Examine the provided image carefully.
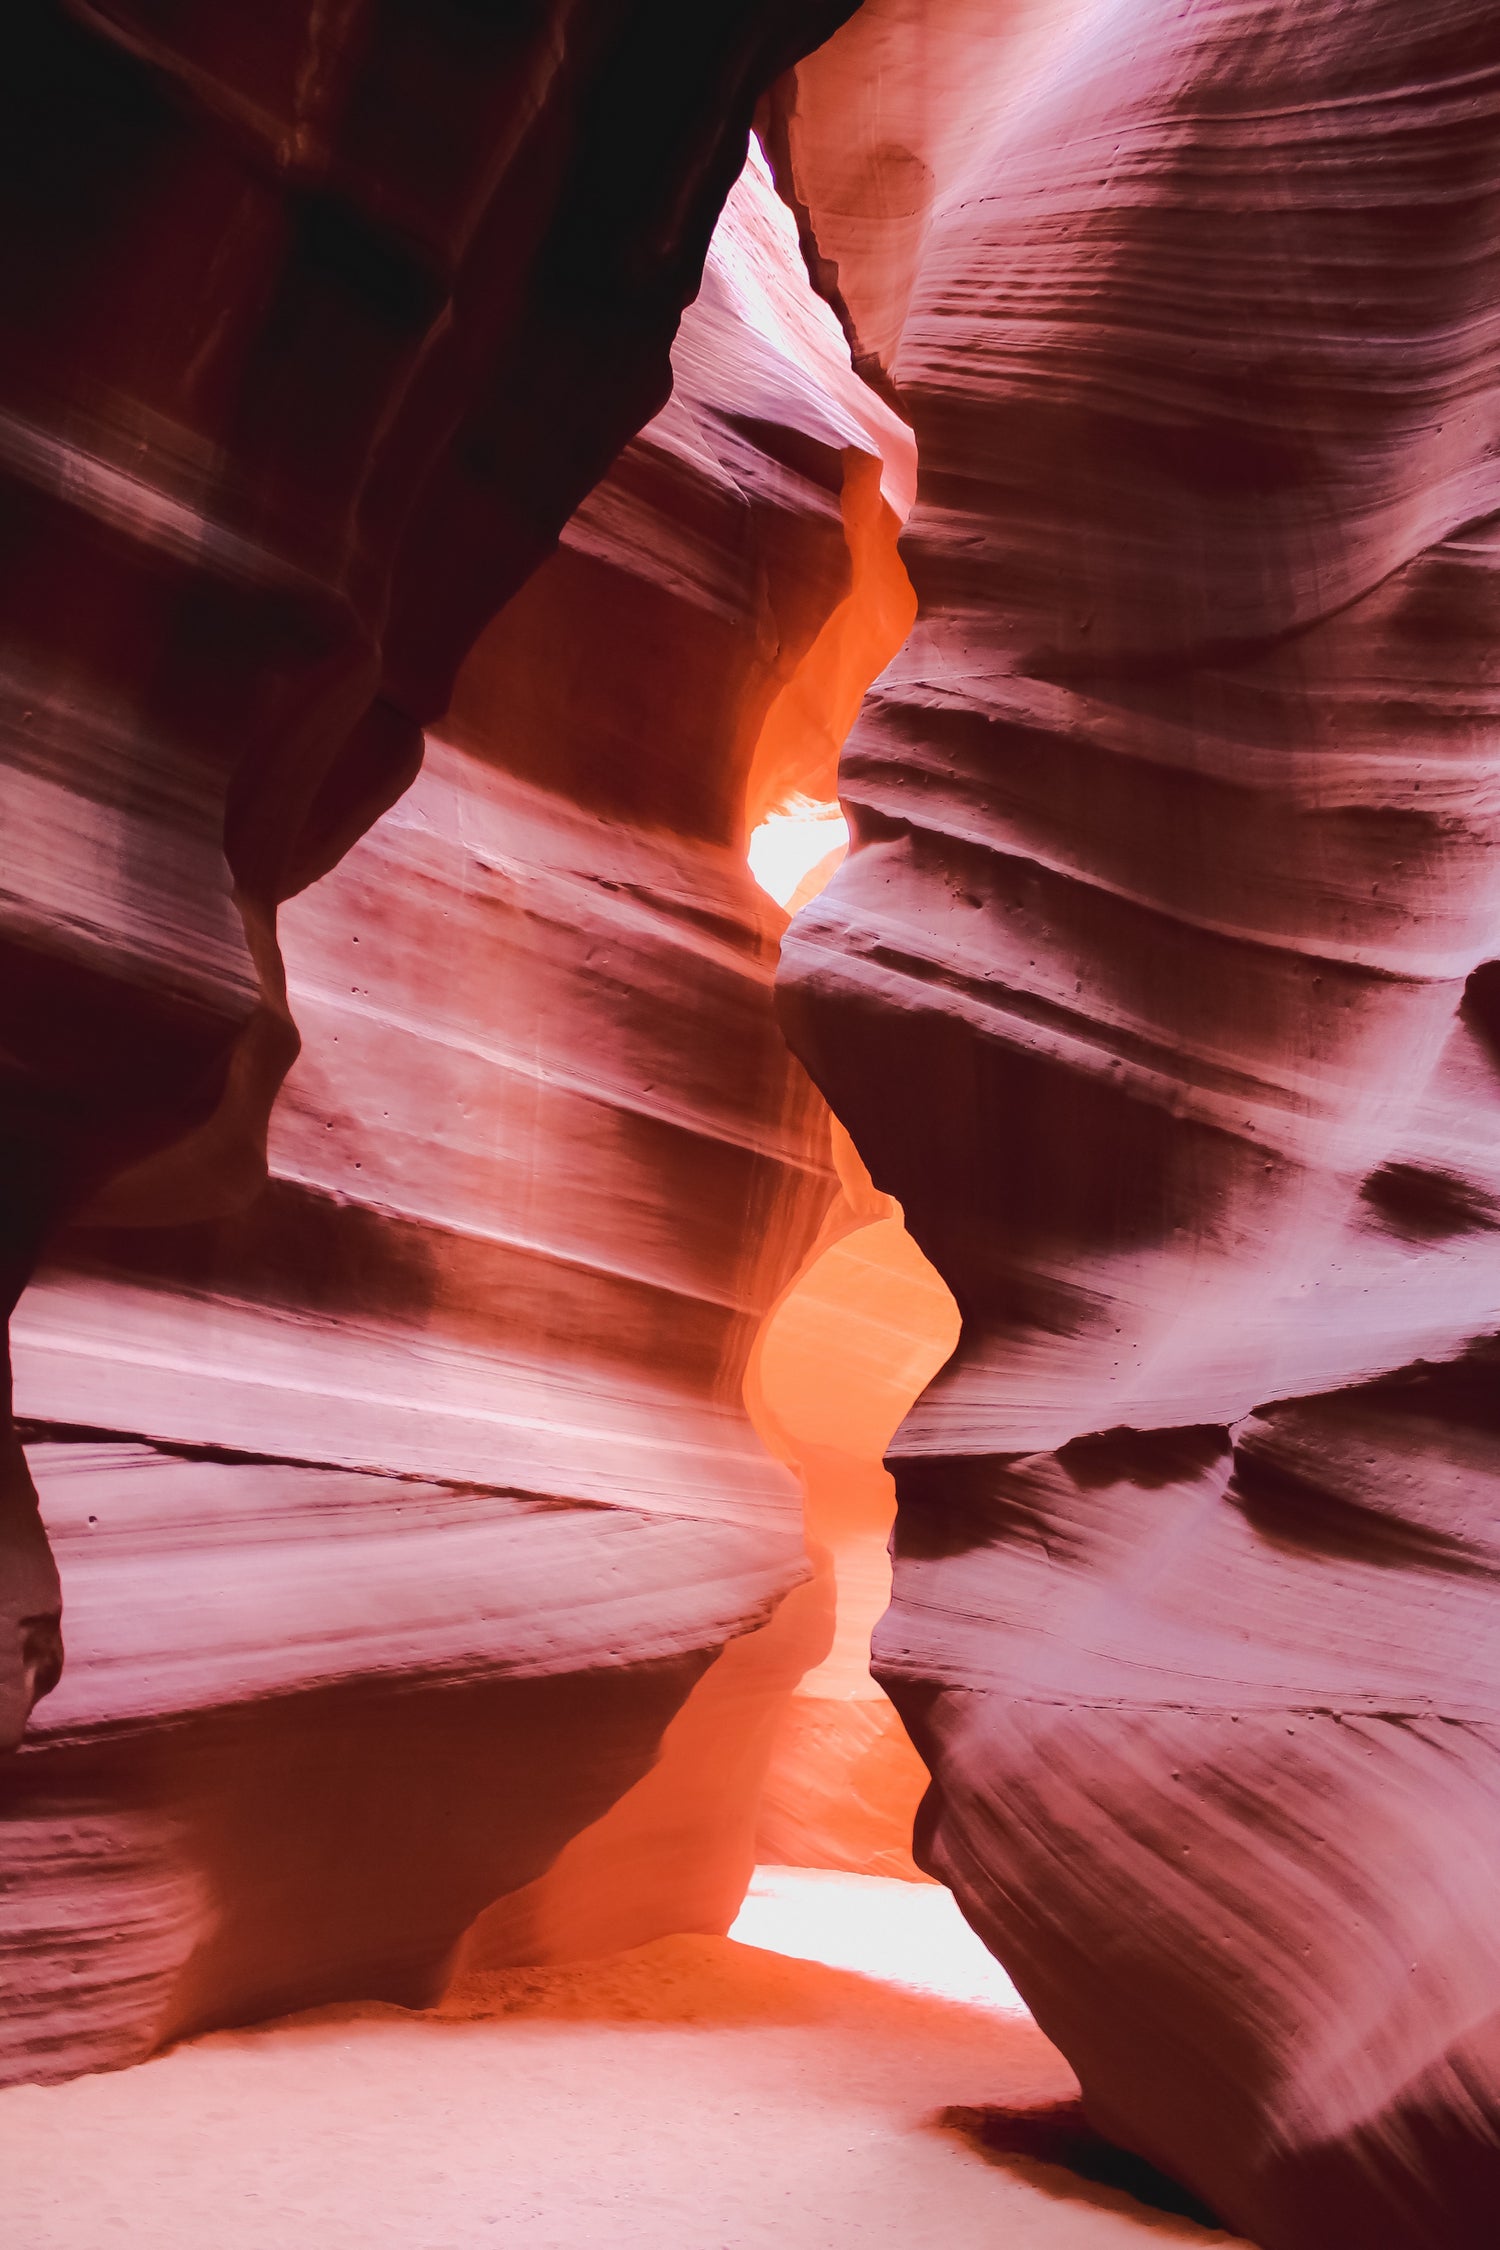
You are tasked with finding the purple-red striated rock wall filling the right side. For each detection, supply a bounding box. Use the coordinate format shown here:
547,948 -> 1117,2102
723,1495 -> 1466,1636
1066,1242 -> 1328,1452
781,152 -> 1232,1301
778,0 -> 1500,2250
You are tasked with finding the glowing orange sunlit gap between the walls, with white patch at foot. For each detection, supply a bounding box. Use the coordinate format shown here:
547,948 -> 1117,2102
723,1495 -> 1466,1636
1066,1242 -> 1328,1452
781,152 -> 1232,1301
731,652 -> 962,2009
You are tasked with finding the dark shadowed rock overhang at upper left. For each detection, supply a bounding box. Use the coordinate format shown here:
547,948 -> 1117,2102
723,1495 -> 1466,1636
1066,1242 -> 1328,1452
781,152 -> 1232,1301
0,0 -> 868,1742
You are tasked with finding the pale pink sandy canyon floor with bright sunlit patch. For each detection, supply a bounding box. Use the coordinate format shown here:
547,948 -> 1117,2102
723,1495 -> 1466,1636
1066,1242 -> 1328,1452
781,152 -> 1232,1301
0,1870 -> 1259,2250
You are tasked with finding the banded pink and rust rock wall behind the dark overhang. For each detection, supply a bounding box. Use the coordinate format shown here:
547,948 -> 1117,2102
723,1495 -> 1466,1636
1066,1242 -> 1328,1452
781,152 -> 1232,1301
0,136 -> 917,2077
